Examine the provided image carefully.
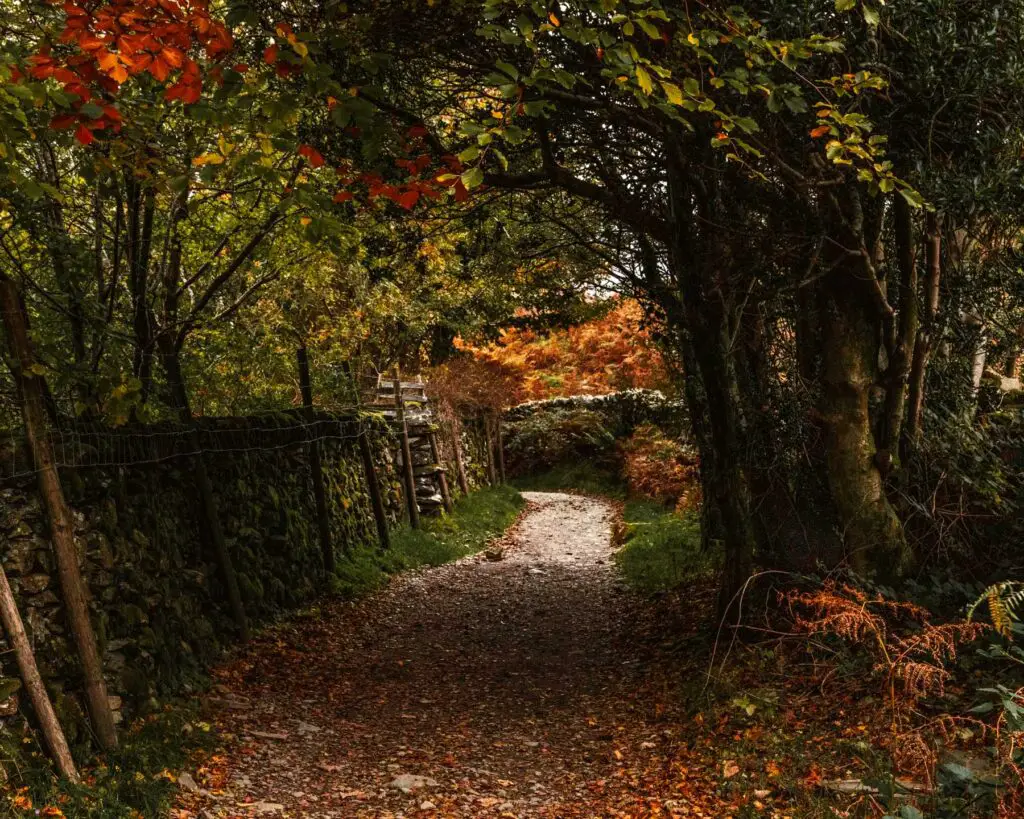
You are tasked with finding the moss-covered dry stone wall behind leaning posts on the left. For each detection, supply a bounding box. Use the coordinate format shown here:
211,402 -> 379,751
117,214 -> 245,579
0,414 -> 417,741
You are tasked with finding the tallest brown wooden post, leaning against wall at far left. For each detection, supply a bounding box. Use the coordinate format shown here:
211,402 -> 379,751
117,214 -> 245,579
0,273 -> 118,750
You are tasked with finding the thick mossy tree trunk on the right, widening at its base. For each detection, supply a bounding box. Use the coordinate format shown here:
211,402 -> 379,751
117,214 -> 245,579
821,261 -> 909,576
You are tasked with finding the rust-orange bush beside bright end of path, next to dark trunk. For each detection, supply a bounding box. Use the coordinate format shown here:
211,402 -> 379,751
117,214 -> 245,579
620,424 -> 700,510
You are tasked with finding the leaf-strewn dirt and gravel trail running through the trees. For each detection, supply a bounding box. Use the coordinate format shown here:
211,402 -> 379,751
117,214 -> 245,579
179,492 -> 716,817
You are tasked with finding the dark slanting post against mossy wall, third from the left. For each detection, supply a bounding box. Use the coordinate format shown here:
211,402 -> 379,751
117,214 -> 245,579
158,333 -> 249,643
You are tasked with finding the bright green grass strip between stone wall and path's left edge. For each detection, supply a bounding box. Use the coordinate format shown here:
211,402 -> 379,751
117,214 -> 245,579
334,486 -> 525,598
